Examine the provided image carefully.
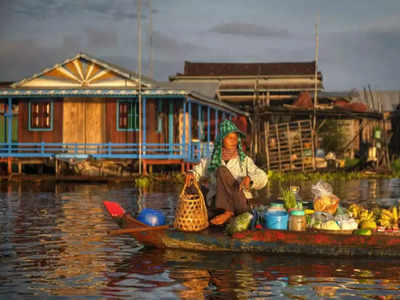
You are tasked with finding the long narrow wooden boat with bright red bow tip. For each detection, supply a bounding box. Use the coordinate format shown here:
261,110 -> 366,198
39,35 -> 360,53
104,201 -> 400,257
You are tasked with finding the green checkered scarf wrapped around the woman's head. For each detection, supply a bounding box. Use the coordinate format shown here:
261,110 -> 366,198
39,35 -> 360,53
208,120 -> 246,173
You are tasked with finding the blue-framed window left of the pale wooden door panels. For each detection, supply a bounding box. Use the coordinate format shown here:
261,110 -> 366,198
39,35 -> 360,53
29,101 -> 53,131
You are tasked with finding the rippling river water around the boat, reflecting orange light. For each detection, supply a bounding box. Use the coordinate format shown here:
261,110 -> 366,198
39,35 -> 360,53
0,179 -> 400,299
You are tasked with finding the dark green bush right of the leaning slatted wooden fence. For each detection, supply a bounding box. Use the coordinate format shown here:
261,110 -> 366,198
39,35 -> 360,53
318,120 -> 346,154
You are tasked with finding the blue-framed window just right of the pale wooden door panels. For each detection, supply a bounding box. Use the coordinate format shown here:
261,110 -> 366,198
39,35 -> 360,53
117,100 -> 139,130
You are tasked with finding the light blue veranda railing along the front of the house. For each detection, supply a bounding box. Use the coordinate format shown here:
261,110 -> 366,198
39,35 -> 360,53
0,142 -> 212,163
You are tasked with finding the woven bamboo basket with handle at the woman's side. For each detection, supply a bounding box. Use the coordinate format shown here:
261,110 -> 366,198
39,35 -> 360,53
174,181 -> 208,231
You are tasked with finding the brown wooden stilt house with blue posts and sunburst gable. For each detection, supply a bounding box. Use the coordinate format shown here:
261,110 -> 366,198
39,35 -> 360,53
0,53 -> 247,175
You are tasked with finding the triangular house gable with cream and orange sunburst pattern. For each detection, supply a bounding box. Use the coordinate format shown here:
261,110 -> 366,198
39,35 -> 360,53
12,54 -> 151,88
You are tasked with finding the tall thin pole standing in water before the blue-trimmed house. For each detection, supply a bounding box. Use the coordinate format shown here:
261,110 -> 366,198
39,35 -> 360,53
137,0 -> 142,175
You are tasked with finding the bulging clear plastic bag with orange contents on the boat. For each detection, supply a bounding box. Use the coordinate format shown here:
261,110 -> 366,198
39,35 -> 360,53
311,180 -> 340,215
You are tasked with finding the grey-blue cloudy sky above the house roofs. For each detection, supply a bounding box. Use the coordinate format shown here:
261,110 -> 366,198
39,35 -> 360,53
0,0 -> 400,91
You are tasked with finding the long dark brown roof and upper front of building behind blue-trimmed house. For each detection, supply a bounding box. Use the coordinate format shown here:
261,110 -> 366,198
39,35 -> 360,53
169,61 -> 323,111
